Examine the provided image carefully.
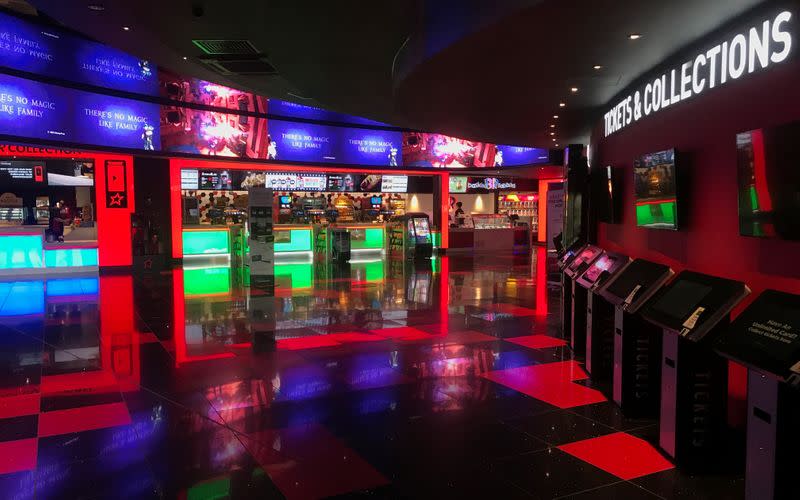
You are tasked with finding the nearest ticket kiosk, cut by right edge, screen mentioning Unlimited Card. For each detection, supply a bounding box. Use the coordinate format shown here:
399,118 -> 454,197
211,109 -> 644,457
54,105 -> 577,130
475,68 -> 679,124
714,290 -> 800,500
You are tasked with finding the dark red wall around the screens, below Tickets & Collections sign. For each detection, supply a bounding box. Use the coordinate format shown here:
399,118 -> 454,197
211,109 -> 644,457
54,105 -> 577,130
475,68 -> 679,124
592,61 -> 800,300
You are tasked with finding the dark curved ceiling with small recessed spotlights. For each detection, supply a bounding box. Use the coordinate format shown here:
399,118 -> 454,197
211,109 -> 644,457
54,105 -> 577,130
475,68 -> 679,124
31,0 -> 761,147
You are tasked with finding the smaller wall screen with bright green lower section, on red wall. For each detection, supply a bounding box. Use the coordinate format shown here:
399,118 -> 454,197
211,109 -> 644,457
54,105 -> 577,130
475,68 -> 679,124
633,149 -> 678,230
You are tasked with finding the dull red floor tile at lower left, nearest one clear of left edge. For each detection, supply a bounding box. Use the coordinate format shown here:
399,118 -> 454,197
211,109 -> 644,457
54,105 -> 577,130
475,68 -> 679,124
39,403 -> 131,437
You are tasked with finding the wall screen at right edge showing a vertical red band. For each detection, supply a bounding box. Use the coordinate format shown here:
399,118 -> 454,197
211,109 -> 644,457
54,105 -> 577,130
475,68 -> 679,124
736,121 -> 800,240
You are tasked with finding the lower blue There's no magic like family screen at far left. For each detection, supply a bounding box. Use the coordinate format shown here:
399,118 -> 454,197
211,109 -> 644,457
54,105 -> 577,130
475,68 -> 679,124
0,75 -> 160,151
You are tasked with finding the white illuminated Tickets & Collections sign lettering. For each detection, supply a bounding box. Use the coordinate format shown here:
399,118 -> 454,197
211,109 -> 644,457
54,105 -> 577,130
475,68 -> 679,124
604,10 -> 796,137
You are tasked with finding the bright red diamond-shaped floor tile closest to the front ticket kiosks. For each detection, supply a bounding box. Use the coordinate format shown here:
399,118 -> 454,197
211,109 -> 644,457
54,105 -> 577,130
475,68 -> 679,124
558,432 -> 675,480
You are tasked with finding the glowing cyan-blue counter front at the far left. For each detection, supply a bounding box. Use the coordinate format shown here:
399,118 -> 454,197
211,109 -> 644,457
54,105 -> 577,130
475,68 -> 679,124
0,226 -> 99,275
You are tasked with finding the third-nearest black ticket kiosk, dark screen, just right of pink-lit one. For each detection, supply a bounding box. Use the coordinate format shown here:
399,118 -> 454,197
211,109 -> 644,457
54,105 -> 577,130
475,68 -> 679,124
597,259 -> 674,417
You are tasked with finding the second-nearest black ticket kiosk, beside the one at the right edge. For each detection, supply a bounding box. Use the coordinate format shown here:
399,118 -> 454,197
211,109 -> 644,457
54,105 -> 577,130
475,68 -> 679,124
641,271 -> 750,469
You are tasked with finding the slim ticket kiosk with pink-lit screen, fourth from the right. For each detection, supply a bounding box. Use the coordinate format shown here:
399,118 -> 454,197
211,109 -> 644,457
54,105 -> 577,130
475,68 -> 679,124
576,251 -> 630,380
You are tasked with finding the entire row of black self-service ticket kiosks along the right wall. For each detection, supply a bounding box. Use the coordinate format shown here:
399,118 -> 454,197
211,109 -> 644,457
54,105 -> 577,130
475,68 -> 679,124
559,245 -> 800,499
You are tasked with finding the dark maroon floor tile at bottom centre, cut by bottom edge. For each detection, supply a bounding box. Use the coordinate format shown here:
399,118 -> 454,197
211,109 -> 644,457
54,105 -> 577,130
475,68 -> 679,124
245,424 -> 389,500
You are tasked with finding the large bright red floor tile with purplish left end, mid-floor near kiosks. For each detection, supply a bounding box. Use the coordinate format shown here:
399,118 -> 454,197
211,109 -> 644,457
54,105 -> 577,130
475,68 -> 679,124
481,361 -> 606,408
